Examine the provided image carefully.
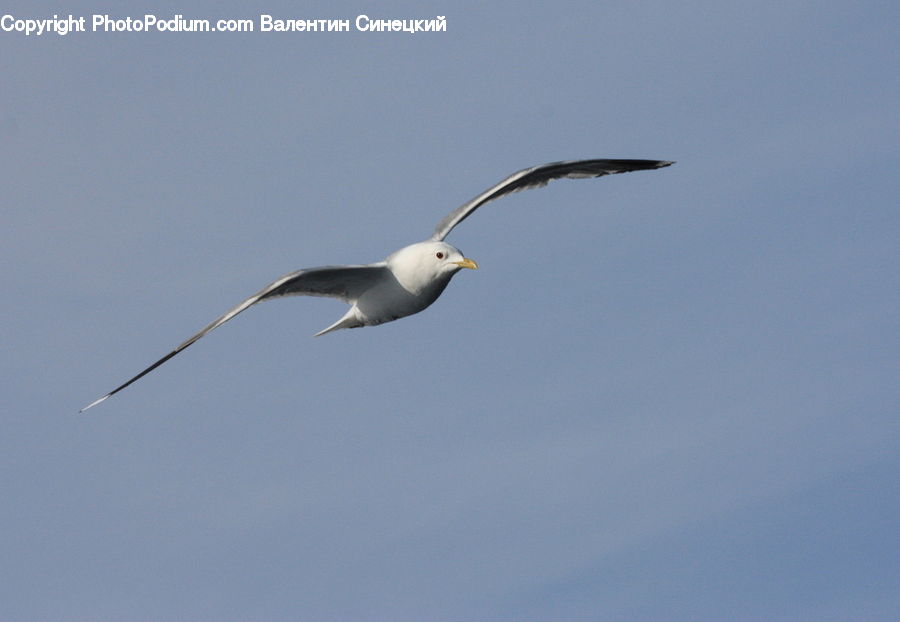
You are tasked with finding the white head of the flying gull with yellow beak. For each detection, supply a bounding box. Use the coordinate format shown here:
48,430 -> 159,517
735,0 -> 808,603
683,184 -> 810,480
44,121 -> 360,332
385,241 -> 478,293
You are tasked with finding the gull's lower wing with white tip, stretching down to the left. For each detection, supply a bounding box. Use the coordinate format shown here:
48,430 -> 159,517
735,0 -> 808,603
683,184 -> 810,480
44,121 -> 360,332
78,263 -> 387,412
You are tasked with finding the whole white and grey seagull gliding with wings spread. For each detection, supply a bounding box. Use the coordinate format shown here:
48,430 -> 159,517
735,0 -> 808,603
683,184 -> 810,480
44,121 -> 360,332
78,159 -> 674,412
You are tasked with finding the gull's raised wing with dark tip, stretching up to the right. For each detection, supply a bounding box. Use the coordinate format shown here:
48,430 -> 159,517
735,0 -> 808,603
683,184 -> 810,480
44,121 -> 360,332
431,160 -> 674,241
